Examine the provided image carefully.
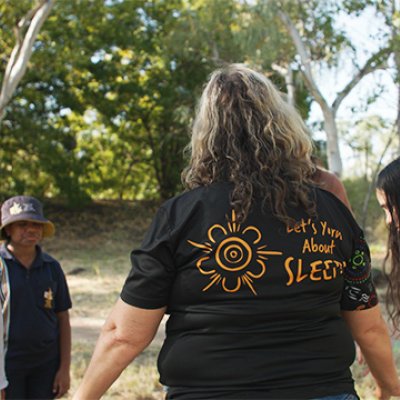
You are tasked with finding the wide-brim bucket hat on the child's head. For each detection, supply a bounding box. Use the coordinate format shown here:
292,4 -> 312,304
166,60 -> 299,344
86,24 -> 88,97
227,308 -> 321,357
0,196 -> 55,239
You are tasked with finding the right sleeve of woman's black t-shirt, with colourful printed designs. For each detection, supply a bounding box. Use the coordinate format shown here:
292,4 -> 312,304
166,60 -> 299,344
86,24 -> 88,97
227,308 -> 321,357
341,230 -> 378,311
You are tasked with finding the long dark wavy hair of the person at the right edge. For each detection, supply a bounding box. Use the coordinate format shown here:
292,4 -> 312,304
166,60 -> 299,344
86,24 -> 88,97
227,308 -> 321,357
376,157 -> 400,331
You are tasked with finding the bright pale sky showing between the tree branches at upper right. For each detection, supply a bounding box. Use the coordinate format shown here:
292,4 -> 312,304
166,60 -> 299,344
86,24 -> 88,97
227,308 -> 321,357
308,6 -> 398,176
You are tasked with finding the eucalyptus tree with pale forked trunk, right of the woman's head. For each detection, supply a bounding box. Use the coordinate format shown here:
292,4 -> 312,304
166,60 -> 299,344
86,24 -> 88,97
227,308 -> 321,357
244,0 -> 389,175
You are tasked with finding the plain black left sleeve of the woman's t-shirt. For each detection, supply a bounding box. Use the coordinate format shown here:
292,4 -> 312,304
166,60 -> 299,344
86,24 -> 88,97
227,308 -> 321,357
121,208 -> 175,309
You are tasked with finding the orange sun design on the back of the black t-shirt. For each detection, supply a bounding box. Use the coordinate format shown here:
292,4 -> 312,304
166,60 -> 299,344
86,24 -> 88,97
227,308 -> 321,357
188,210 -> 282,295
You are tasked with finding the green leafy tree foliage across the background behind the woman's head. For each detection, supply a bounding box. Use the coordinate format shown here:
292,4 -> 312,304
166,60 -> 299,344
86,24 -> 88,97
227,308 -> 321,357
0,0 -> 378,204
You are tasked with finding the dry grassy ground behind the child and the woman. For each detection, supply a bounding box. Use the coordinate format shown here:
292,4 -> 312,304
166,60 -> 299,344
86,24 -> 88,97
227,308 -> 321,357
39,203 -> 400,400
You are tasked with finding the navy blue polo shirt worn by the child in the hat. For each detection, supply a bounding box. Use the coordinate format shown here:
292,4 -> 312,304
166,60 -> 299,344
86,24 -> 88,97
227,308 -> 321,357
0,244 -> 72,370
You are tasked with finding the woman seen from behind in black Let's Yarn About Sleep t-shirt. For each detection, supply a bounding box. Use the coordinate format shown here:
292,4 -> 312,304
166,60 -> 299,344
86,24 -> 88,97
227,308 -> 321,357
74,64 -> 400,400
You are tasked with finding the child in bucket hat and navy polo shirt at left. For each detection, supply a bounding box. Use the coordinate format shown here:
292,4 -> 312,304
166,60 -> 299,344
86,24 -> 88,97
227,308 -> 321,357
0,196 -> 71,399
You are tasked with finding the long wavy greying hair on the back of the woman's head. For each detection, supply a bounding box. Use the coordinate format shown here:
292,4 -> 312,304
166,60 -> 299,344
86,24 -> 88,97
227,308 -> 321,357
183,64 -> 314,222
